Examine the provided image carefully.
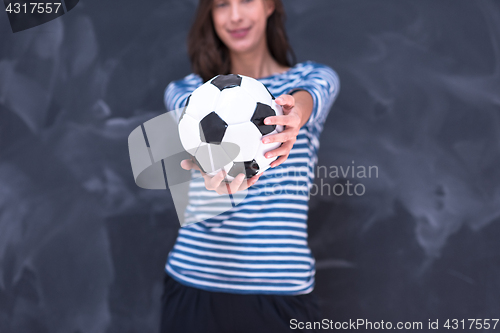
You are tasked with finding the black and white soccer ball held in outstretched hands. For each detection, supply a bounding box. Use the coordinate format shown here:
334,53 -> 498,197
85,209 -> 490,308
179,74 -> 283,181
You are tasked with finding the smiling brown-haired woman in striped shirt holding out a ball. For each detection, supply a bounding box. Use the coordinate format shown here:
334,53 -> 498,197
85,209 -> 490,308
161,0 -> 339,333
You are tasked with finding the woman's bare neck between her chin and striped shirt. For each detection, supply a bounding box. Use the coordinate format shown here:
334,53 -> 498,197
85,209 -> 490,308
230,40 -> 287,79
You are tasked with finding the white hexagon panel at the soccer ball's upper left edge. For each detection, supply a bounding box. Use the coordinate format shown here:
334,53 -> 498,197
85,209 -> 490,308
186,84 -> 220,121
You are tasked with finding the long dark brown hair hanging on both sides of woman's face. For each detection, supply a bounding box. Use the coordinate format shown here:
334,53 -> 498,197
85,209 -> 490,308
187,0 -> 296,82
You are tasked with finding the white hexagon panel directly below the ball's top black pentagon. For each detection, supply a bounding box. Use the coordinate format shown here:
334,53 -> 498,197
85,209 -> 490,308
215,87 -> 257,124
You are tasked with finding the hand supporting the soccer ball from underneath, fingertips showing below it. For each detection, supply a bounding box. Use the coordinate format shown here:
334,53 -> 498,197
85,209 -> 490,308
181,160 -> 260,194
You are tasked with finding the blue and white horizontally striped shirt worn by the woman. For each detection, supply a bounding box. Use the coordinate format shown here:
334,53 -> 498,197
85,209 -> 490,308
164,61 -> 340,295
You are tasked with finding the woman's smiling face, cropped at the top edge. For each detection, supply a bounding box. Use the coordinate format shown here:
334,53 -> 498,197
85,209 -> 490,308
212,0 -> 274,53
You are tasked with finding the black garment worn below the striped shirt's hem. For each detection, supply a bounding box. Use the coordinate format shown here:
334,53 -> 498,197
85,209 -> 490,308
160,274 -> 321,333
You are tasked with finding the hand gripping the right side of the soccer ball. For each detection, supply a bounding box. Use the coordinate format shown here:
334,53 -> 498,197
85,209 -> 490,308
262,94 -> 301,168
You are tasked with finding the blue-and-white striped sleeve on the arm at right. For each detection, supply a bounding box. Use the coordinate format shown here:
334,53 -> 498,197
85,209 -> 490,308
288,61 -> 340,127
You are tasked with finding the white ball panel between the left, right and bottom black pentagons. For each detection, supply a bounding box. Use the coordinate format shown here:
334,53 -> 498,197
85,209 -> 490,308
223,121 -> 262,161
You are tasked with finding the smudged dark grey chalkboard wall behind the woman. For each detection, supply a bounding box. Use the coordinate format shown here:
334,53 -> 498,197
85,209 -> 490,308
0,0 -> 500,333
